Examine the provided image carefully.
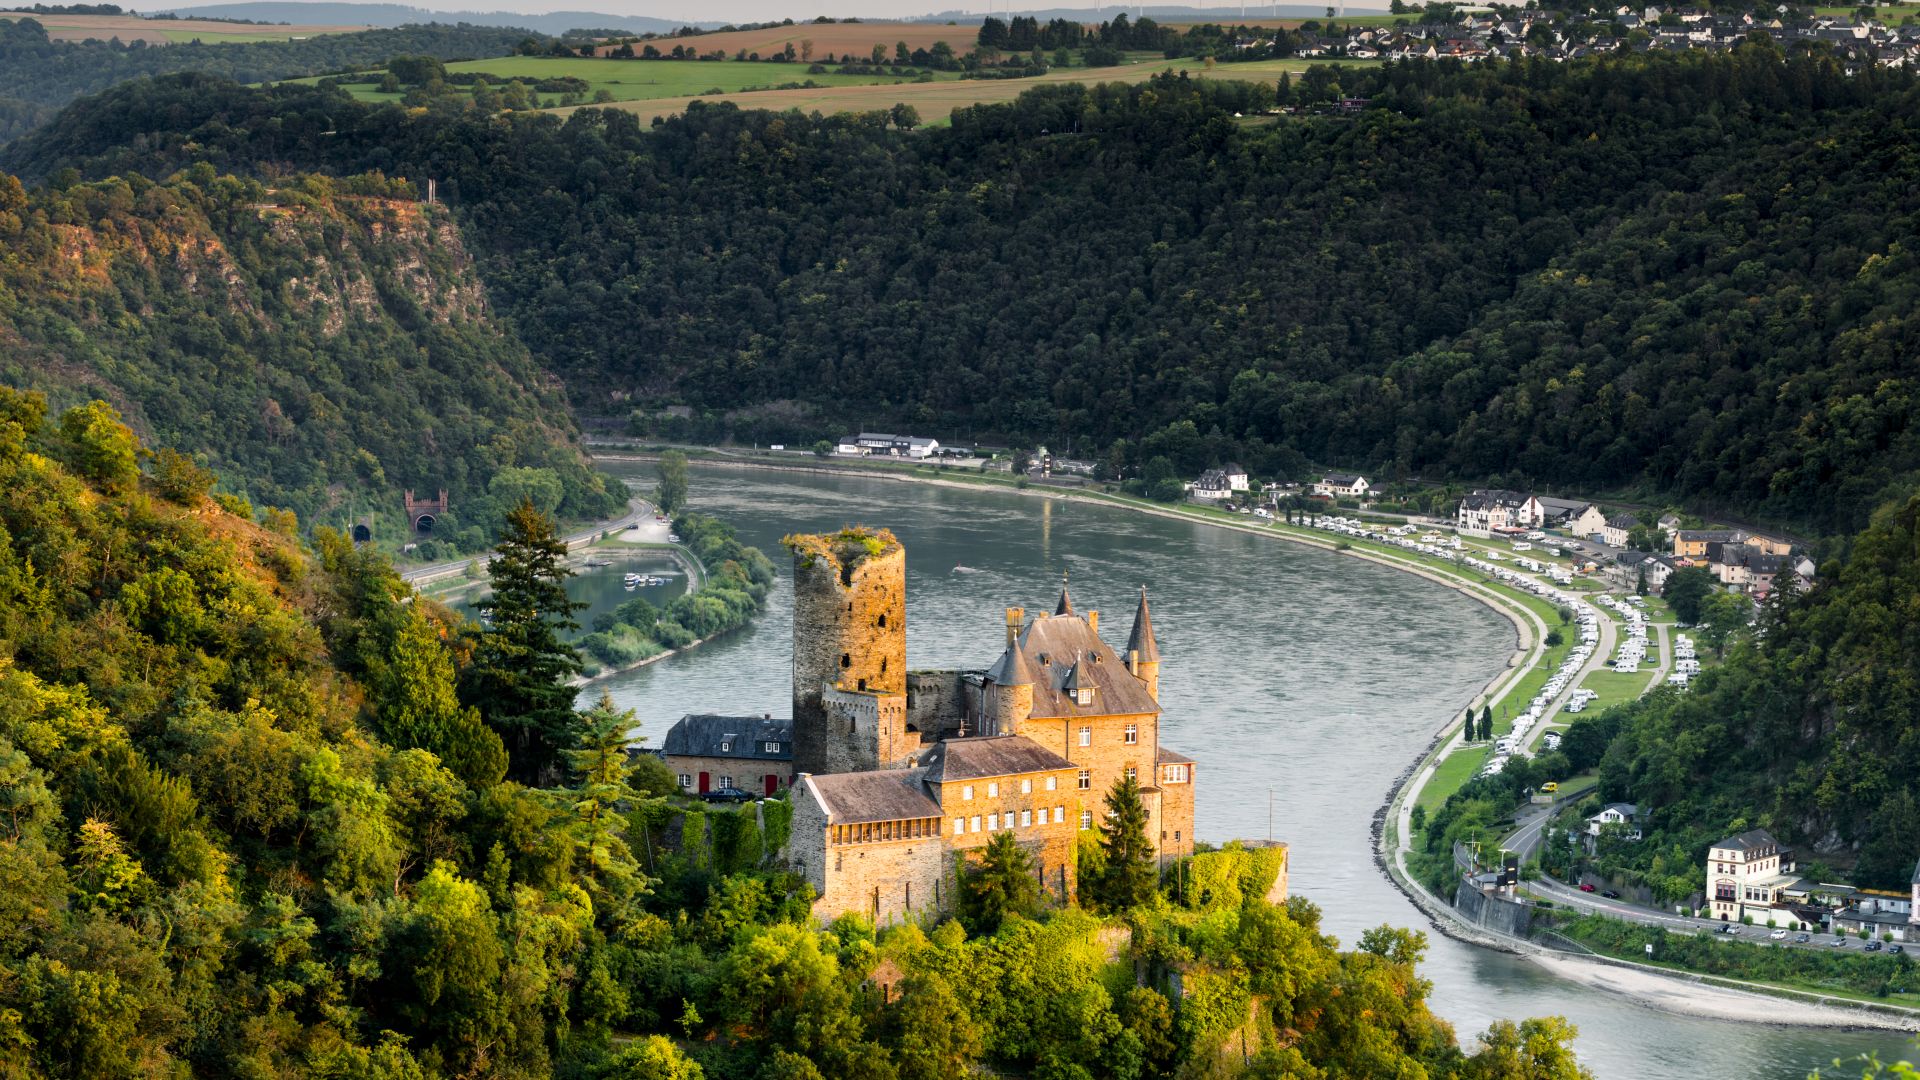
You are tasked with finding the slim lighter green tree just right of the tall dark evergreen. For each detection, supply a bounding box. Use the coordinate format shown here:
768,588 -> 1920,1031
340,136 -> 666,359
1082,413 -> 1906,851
566,692 -> 647,899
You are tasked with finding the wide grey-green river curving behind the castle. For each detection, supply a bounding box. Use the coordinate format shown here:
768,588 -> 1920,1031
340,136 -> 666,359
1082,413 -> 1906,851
591,457 -> 1908,1080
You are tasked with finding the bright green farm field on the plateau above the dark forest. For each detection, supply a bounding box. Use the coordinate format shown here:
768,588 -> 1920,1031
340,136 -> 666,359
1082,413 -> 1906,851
296,56 -> 954,111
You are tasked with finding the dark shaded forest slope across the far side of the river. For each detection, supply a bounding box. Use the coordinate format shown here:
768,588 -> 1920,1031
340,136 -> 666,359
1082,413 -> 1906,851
4,42 -> 1920,530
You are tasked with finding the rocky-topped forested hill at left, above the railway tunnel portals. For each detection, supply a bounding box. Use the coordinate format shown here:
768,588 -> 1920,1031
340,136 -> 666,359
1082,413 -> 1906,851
0,165 -> 618,548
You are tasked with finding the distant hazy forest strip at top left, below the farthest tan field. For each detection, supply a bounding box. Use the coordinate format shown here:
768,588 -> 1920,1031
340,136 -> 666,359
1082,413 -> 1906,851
0,19 -> 526,114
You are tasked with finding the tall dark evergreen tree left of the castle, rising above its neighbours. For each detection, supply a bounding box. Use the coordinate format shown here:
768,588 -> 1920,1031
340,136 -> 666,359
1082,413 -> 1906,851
467,502 -> 582,786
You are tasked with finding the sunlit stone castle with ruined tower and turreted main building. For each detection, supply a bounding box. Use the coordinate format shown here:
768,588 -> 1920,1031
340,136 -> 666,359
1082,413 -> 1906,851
771,528 -> 1194,922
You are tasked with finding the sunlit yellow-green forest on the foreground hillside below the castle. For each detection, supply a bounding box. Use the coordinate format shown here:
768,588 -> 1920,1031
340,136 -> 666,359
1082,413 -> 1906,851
0,390 -> 1590,1080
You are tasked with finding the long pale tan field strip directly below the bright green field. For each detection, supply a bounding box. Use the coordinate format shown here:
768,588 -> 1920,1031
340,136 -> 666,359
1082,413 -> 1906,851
555,60 -> 1365,125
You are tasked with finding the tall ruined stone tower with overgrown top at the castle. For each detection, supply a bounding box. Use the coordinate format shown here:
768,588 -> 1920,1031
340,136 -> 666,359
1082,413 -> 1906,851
785,528 -> 920,773
